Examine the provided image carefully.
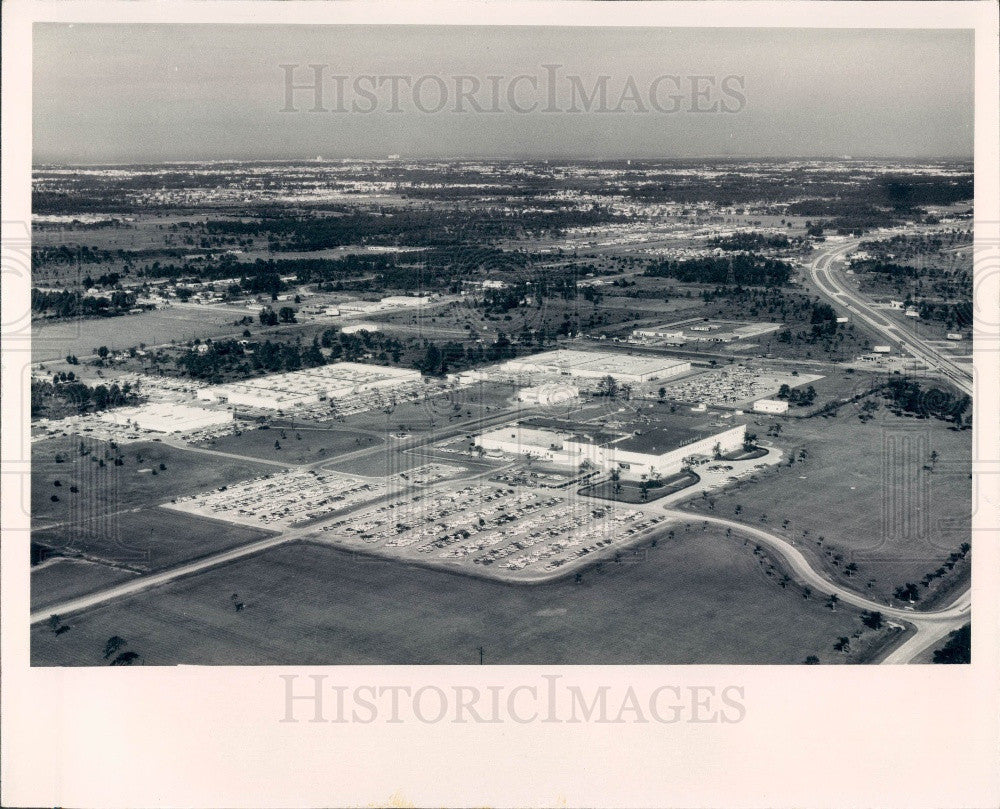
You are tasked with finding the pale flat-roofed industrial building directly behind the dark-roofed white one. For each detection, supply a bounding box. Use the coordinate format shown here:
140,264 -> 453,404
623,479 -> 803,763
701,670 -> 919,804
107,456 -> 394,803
500,348 -> 691,383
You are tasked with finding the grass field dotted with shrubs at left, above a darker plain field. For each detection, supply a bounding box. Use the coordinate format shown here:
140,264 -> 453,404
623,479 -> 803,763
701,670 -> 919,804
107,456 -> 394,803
31,436 -> 274,528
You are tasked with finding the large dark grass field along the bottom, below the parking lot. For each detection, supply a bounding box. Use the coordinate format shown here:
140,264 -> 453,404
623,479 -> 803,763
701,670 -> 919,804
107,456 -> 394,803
32,531 -> 892,665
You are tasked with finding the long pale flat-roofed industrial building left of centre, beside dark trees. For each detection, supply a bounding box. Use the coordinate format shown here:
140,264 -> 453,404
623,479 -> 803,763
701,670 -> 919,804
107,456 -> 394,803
198,362 -> 421,410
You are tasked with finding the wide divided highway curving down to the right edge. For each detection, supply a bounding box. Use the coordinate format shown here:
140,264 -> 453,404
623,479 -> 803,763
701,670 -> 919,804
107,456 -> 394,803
806,239 -> 972,396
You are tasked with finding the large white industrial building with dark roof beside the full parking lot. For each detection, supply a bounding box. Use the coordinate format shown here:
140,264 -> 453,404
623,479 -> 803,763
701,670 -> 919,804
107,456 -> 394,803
474,419 -> 746,480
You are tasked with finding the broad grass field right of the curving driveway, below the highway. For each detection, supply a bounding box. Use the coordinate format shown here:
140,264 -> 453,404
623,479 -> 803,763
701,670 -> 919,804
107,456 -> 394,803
687,406 -> 972,607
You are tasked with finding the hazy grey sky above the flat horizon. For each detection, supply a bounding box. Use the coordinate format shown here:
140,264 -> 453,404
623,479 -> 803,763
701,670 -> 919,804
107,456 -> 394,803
32,23 -> 974,164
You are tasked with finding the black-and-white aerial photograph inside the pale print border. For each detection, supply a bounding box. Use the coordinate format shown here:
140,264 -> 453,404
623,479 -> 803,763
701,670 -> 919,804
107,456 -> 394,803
30,23 -> 975,667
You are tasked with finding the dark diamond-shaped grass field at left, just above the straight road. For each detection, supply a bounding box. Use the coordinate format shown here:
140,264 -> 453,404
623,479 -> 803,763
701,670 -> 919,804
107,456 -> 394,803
32,507 -> 278,571
